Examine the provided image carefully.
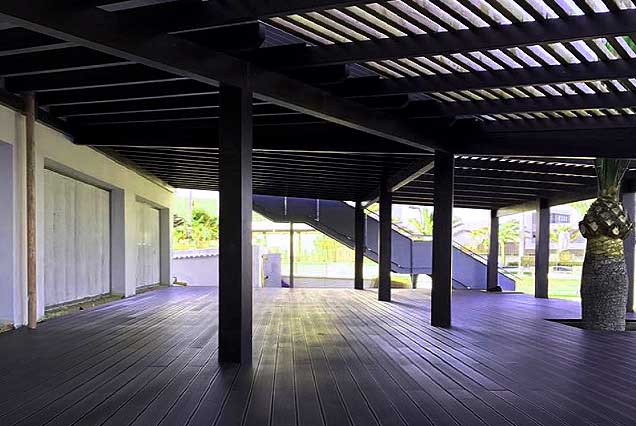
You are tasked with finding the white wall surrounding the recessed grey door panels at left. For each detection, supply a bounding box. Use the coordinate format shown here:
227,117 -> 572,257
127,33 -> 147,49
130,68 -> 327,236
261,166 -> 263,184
0,106 -> 173,325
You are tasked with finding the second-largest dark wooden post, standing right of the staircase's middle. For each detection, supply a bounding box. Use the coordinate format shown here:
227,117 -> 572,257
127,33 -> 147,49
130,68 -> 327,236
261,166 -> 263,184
431,151 -> 455,327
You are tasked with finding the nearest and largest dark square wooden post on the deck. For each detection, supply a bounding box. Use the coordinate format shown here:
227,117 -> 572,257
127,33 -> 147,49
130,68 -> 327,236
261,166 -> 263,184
219,85 -> 252,364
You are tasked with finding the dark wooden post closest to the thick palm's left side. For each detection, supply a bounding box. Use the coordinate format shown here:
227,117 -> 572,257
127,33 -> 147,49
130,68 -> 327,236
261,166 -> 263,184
534,198 -> 550,299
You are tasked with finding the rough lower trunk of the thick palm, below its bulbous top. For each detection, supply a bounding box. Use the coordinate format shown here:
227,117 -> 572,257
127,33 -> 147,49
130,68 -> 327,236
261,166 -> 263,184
581,236 -> 628,331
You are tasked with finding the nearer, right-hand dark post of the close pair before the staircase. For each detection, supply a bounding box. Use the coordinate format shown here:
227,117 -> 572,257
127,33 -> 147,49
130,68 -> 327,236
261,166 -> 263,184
378,179 -> 393,302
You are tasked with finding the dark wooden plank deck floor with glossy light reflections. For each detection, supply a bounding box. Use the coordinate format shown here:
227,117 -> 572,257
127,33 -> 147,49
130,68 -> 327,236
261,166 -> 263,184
0,288 -> 636,426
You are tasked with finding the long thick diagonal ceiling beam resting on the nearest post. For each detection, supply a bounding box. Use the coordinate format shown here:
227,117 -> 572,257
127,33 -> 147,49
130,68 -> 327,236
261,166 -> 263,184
0,0 -> 443,150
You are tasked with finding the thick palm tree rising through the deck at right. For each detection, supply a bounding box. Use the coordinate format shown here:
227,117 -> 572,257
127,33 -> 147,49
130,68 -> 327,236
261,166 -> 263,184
579,158 -> 634,331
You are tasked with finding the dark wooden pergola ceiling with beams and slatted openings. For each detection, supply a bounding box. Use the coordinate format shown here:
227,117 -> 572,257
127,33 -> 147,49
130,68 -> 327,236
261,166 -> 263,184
0,0 -> 636,211
